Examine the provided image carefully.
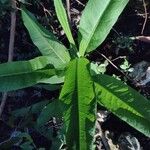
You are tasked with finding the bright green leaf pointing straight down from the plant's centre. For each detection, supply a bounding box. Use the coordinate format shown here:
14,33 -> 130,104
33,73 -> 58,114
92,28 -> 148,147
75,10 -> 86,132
59,58 -> 96,150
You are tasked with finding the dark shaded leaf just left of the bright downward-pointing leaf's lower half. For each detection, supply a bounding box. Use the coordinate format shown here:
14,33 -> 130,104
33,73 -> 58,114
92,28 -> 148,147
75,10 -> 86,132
35,100 -> 64,150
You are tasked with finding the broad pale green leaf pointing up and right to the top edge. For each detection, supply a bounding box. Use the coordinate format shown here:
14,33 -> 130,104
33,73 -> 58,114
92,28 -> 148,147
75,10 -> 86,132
79,0 -> 129,56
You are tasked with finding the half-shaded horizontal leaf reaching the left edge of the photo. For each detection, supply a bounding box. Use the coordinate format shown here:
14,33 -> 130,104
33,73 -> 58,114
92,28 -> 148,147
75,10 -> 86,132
0,56 -> 56,92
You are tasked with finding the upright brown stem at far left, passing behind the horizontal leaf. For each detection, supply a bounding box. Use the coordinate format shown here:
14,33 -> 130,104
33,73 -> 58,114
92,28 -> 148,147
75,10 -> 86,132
0,0 -> 17,117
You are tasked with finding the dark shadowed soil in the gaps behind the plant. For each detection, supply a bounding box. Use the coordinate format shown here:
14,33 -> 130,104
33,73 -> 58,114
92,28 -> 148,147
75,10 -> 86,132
0,0 -> 150,150
